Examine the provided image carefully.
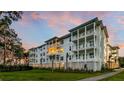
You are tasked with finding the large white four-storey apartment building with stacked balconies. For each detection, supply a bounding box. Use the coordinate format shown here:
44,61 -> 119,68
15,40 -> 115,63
29,17 -> 118,71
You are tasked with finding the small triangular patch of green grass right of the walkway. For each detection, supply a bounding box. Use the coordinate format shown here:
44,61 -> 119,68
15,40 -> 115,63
102,71 -> 124,81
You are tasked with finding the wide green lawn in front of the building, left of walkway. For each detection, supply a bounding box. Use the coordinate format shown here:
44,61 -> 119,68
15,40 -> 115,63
0,69 -> 102,81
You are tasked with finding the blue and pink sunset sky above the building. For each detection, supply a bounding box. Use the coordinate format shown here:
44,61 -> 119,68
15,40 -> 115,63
11,11 -> 124,56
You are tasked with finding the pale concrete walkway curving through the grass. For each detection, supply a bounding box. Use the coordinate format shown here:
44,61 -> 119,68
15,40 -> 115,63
79,68 -> 124,81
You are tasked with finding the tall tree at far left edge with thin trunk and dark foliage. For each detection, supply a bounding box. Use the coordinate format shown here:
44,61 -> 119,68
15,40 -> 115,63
0,11 -> 23,64
